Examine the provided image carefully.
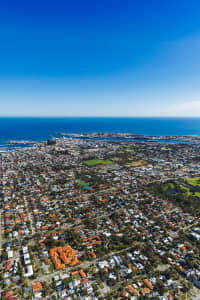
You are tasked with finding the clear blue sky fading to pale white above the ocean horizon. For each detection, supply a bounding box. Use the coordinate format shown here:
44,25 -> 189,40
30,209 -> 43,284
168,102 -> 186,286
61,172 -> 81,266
0,0 -> 200,116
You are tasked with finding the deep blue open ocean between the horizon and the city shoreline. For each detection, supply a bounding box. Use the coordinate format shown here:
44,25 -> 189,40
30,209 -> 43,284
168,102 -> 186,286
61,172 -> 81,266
0,117 -> 200,148
